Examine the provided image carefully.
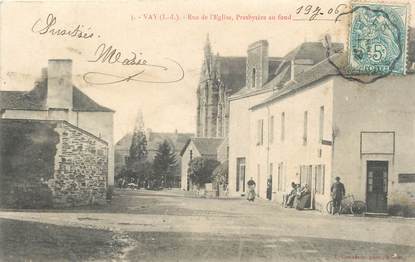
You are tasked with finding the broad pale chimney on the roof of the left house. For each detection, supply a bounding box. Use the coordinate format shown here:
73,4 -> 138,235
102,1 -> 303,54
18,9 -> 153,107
46,59 -> 72,109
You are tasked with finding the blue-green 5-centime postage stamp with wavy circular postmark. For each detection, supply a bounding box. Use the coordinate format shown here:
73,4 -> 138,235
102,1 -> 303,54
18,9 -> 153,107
347,3 -> 409,75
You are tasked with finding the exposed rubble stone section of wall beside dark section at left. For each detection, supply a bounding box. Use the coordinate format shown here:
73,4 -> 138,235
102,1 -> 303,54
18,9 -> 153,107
48,122 -> 108,207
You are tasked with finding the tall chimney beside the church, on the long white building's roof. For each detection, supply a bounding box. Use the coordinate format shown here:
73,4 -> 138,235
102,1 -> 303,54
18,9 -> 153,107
246,40 -> 269,88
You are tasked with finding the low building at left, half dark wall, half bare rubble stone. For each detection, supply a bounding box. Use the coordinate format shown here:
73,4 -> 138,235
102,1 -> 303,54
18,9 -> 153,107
0,119 -> 109,208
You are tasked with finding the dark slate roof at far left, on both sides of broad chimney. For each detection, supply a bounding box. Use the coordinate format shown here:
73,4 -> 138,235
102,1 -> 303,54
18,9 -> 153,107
0,81 -> 114,112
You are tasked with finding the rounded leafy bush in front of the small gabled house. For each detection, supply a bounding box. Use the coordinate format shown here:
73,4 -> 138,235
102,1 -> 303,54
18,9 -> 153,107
188,157 -> 220,187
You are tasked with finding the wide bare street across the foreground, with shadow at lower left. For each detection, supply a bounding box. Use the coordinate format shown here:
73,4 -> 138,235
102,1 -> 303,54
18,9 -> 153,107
0,189 -> 415,261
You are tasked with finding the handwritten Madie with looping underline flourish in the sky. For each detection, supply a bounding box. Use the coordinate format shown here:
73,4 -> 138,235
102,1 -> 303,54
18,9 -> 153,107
83,44 -> 184,85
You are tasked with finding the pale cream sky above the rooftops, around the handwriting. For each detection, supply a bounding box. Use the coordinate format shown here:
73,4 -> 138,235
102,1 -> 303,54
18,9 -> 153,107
0,0 -> 414,141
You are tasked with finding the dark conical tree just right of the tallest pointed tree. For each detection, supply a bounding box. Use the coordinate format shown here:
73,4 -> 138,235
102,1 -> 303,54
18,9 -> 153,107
153,140 -> 177,187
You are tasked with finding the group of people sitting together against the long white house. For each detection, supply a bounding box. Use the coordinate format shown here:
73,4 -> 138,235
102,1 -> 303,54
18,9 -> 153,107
283,182 -> 311,210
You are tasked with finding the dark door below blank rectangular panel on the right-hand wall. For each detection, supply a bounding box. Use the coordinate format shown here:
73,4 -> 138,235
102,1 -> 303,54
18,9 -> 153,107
366,161 -> 388,213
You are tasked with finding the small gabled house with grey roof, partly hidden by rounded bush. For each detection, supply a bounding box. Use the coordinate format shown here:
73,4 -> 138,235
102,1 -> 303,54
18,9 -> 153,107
180,137 -> 223,191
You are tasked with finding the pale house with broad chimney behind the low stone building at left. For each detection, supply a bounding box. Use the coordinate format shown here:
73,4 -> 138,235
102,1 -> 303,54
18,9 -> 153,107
0,59 -> 114,185
